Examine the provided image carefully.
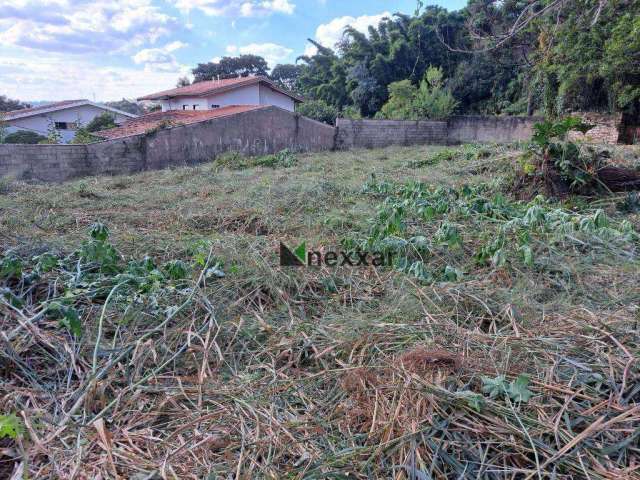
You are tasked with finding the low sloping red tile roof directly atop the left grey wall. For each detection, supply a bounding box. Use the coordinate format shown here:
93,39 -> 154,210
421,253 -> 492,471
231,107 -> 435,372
93,105 -> 268,140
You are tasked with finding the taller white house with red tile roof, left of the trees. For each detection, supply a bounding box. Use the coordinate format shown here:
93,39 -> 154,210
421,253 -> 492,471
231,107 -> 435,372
138,76 -> 303,112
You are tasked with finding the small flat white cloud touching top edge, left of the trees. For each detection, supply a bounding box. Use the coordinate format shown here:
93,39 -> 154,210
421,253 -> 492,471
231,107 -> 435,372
169,0 -> 296,17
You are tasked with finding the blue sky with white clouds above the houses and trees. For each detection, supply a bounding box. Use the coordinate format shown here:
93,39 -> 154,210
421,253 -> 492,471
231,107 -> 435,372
0,0 -> 466,101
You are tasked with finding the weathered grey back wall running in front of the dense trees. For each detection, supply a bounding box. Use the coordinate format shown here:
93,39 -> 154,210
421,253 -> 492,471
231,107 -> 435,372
336,116 -> 542,148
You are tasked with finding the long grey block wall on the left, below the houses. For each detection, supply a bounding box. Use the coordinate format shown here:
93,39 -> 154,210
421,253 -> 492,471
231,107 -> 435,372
0,107 -> 336,182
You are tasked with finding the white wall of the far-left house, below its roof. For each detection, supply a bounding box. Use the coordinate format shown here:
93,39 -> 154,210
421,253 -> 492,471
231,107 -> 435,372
7,105 -> 129,143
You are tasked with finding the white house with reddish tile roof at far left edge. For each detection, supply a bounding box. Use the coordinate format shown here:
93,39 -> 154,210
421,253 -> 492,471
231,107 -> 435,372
2,99 -> 136,143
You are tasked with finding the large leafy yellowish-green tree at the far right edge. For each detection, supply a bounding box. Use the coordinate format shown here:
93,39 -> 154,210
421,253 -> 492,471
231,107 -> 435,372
536,0 -> 640,116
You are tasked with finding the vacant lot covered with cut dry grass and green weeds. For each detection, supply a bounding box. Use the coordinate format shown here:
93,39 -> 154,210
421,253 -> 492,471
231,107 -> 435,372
0,146 -> 640,479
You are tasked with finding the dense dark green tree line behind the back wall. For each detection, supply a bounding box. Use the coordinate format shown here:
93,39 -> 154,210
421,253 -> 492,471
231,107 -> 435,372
188,0 -> 640,119
